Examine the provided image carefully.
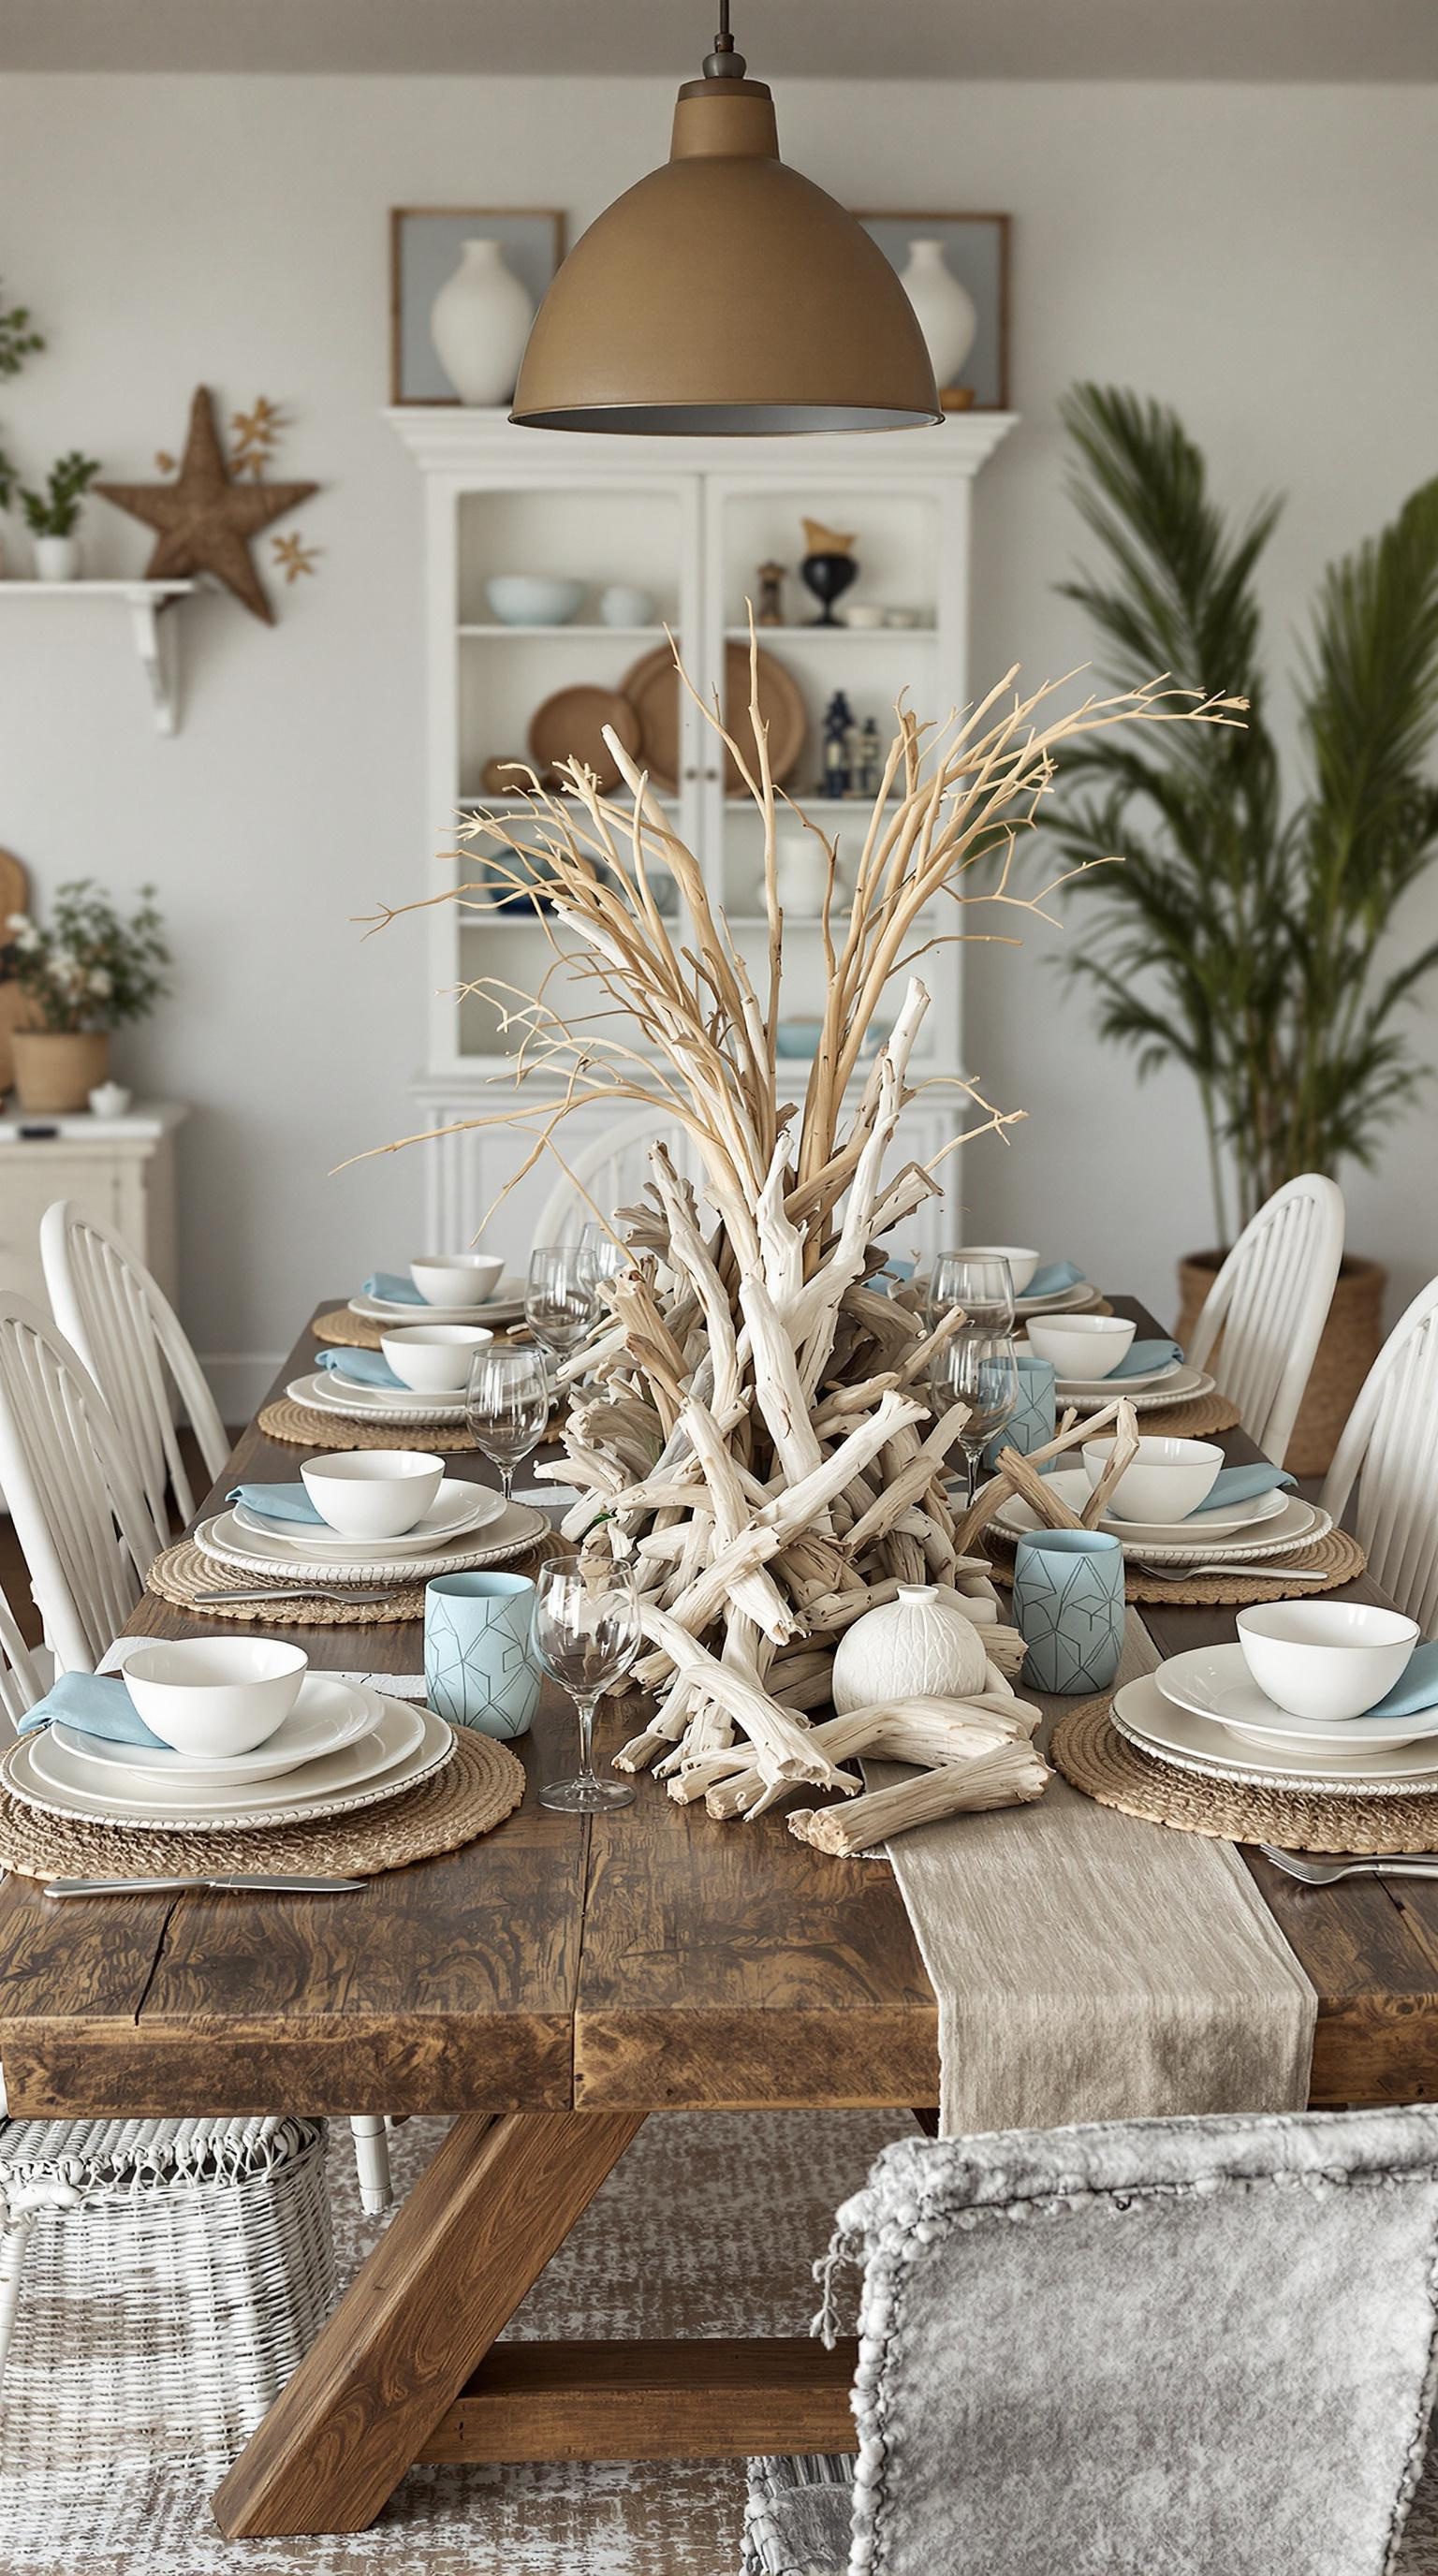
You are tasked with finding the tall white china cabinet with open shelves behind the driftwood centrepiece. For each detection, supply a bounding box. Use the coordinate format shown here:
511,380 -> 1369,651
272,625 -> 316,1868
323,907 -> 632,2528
389,407 -> 1013,1250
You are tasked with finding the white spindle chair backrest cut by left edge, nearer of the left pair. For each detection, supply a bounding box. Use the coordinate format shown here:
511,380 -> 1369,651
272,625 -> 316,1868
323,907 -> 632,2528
0,1288 -> 154,1672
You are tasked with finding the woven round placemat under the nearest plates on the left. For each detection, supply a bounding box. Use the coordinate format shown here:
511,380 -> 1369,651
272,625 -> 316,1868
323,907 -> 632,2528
0,1726 -> 523,1878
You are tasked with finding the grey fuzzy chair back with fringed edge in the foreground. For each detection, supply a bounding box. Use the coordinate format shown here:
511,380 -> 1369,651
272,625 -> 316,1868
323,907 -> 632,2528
814,2107 -> 1438,2576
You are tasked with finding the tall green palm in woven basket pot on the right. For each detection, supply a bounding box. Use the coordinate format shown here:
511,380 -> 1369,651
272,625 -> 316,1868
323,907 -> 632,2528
1057,384 -> 1438,1473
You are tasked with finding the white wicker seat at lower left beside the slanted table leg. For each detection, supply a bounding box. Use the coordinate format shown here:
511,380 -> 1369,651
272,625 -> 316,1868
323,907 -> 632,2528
0,2120 -> 335,2472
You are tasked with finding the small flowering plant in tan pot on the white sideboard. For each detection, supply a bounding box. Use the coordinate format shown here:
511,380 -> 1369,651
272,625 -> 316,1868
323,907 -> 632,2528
0,878 -> 170,1116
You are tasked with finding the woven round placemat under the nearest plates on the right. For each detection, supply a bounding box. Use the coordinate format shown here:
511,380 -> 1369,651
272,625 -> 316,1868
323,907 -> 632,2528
1049,1698 -> 1438,1852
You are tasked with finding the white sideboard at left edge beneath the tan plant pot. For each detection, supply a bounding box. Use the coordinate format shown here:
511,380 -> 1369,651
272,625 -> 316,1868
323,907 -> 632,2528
0,1100 -> 188,1314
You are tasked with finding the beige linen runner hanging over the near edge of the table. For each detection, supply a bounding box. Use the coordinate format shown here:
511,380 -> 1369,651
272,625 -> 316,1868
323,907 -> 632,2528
889,1613 -> 1317,2135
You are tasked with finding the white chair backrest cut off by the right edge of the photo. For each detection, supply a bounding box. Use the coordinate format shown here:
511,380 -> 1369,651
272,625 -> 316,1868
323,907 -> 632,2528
1322,1281 -> 1438,1636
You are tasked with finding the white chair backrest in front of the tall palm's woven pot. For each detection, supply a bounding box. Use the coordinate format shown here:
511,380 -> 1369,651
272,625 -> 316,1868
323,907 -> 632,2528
1188,1172 -> 1343,1466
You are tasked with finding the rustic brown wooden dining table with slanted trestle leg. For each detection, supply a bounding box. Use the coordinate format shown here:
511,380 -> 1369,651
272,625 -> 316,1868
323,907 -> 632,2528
0,1298 -> 1438,2538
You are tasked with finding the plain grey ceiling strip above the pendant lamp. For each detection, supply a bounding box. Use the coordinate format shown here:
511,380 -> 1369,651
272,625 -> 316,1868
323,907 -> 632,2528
0,0 -> 1438,80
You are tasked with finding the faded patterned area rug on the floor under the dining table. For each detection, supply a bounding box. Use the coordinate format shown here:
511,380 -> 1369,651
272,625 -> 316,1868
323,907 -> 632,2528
0,2113 -> 910,2576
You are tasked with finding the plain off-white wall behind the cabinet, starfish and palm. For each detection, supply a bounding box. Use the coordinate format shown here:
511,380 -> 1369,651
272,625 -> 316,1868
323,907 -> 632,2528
0,78 -> 1438,1404
